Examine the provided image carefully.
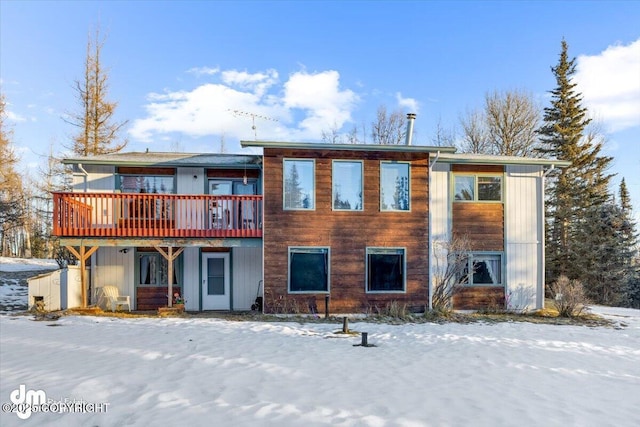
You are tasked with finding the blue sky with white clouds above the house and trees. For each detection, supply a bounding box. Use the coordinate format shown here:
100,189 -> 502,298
0,0 -> 640,215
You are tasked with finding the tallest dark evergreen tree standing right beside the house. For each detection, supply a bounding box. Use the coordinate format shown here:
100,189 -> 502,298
538,40 -> 612,281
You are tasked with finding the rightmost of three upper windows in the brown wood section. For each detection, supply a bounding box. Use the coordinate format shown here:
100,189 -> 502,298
380,162 -> 410,211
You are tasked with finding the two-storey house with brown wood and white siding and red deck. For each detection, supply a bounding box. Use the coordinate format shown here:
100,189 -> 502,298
54,141 -> 566,313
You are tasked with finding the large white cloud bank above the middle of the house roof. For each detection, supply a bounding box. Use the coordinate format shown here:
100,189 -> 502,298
129,69 -> 359,142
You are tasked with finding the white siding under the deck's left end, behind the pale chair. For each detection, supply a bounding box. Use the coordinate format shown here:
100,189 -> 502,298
91,247 -> 136,310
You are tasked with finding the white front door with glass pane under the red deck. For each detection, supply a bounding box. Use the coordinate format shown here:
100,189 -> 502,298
202,252 -> 231,310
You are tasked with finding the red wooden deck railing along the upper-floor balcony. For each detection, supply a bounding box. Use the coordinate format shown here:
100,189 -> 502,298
53,193 -> 262,237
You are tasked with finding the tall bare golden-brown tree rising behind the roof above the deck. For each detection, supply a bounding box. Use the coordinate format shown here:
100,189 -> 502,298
65,28 -> 127,156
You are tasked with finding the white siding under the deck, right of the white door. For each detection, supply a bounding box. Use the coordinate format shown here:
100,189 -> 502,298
231,248 -> 262,310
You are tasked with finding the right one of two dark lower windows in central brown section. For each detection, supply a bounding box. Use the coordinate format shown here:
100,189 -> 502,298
367,248 -> 405,292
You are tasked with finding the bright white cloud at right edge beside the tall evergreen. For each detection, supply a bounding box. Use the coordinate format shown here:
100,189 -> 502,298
575,39 -> 640,132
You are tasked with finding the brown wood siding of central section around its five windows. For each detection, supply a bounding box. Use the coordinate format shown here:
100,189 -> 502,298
263,148 -> 429,313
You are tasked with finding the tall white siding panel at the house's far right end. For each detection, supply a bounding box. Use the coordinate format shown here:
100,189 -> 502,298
504,165 -> 544,310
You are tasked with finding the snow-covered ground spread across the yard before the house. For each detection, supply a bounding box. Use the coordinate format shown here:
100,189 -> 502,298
0,260 -> 640,426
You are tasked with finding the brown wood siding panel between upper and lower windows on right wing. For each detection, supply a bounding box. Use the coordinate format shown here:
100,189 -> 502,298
452,202 -> 504,251
